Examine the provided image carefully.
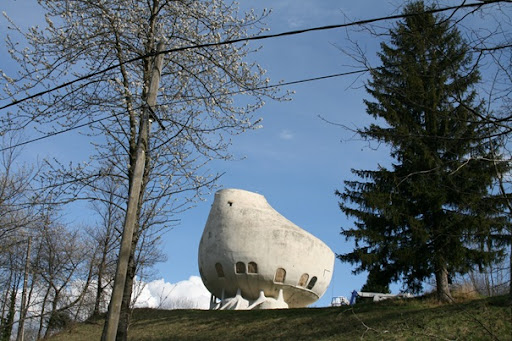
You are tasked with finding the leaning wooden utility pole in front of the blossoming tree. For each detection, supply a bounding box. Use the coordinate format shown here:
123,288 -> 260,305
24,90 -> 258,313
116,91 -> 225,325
101,43 -> 164,341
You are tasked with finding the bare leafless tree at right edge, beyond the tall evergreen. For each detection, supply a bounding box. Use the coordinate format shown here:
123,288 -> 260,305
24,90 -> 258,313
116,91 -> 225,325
440,1 -> 512,297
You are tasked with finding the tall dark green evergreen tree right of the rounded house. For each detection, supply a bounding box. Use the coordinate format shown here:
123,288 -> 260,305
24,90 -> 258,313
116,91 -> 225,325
336,1 -> 505,301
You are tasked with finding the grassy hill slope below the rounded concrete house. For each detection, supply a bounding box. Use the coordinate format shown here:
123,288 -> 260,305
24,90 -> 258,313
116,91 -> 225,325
51,296 -> 512,341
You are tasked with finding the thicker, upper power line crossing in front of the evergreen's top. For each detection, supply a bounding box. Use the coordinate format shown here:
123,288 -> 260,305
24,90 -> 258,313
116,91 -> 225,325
0,0 -> 502,110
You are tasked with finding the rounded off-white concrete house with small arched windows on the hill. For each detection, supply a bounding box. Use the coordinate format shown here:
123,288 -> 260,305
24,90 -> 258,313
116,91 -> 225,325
199,189 -> 334,309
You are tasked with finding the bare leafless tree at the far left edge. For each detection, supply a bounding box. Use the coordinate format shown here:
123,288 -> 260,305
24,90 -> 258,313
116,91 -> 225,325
0,134 -> 42,340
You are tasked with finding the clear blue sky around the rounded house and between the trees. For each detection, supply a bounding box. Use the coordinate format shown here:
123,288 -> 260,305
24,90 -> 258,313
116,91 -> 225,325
0,0 -> 504,306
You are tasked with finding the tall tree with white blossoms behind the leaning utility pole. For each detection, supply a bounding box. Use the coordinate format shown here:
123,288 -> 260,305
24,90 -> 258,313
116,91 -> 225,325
0,0 -> 283,330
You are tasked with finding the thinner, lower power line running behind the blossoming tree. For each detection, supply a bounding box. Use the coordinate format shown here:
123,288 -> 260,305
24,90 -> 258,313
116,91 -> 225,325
0,69 -> 369,152
